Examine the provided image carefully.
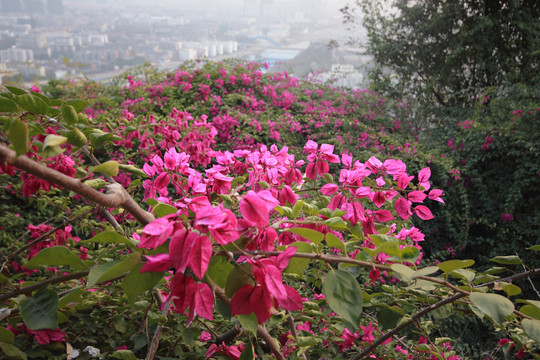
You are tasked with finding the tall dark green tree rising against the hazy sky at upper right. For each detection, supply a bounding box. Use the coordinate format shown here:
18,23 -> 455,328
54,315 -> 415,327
342,0 -> 540,107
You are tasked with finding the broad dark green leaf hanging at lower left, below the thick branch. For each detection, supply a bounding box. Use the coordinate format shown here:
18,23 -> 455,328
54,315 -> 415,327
19,286 -> 58,330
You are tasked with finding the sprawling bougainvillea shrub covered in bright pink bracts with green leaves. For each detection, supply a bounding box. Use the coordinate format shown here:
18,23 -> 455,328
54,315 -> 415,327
0,64 -> 540,360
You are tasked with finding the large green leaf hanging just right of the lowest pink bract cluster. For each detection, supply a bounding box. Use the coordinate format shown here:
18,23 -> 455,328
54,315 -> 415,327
322,270 -> 363,329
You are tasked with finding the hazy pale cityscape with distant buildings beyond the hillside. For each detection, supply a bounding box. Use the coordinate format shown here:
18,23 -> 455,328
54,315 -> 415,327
0,0 -> 370,87
